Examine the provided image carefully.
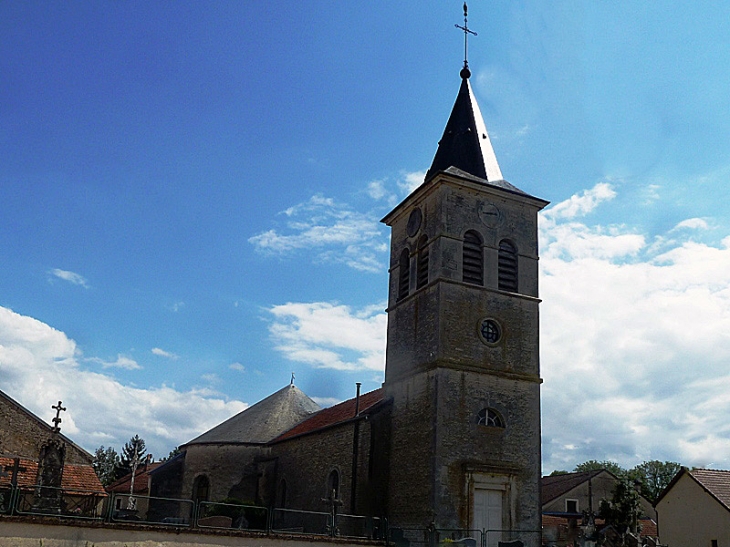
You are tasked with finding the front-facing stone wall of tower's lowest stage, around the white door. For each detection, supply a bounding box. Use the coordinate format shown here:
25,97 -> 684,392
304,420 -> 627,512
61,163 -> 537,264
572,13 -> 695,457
435,369 -> 540,530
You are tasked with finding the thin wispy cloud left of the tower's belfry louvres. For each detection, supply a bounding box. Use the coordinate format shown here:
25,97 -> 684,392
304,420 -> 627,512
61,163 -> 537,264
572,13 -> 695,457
248,195 -> 387,272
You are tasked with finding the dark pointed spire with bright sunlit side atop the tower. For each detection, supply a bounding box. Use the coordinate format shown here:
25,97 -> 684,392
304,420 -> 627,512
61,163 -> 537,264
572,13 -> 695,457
426,68 -> 502,182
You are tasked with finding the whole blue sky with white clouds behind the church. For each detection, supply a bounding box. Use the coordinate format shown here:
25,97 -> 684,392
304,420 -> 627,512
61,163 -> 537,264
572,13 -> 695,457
0,0 -> 730,472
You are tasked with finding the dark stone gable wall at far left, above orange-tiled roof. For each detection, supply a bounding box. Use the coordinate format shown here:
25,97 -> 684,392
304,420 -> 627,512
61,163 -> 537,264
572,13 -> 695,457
0,392 -> 92,465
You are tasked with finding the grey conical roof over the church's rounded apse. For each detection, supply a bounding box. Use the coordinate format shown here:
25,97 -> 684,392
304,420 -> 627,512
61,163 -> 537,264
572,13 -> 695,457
181,384 -> 320,450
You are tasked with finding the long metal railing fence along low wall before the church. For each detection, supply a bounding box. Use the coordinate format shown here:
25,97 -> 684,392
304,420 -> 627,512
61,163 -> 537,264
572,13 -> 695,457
0,486 -> 541,547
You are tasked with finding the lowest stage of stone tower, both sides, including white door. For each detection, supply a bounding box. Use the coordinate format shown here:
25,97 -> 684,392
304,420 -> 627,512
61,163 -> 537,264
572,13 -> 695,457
385,367 -> 540,544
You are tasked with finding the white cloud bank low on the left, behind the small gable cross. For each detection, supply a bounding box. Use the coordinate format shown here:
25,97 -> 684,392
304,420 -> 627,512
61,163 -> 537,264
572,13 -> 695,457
0,306 -> 247,457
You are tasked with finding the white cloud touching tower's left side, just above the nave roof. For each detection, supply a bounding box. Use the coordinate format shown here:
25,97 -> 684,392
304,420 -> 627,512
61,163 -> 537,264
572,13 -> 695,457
268,302 -> 387,371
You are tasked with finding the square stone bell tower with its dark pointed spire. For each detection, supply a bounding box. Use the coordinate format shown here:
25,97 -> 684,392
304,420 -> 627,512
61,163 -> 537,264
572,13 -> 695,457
383,57 -> 548,546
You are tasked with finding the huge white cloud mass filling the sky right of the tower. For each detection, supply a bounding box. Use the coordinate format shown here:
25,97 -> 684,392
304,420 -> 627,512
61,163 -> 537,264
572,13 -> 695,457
540,187 -> 730,472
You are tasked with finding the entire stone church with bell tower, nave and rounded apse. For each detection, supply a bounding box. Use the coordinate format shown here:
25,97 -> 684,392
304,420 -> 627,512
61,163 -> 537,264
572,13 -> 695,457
150,46 -> 548,545
